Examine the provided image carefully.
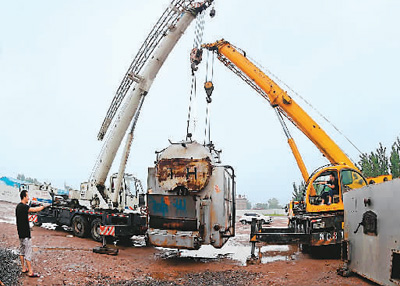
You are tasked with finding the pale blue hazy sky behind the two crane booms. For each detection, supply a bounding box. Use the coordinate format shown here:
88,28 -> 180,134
0,0 -> 400,204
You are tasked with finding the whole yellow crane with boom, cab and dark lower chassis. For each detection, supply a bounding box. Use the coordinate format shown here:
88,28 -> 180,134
202,40 -> 391,246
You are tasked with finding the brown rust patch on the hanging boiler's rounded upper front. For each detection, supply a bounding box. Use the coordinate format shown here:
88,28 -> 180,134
156,158 -> 212,191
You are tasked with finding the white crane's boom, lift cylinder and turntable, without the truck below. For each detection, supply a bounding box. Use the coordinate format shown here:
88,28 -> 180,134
72,0 -> 213,210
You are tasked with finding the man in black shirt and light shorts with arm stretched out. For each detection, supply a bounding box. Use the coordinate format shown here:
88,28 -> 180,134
15,190 -> 45,278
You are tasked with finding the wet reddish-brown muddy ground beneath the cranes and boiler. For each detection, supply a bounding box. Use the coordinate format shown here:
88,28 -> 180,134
0,202 -> 373,286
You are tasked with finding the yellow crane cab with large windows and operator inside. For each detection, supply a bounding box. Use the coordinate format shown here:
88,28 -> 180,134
305,165 -> 367,212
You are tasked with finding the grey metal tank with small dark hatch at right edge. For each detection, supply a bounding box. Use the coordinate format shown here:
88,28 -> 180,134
339,179 -> 400,285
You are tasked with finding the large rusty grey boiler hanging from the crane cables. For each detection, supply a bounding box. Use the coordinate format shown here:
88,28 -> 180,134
147,141 -> 235,249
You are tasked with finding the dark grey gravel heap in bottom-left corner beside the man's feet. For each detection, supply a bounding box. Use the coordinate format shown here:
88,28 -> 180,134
0,248 -> 21,285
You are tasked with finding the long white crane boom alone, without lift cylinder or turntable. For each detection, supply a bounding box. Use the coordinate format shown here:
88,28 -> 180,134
91,0 -> 212,186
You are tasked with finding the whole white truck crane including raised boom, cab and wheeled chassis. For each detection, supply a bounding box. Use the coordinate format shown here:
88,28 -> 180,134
38,0 -> 213,246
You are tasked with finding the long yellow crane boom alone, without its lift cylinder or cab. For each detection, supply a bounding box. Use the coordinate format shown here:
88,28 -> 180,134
202,40 -> 358,170
